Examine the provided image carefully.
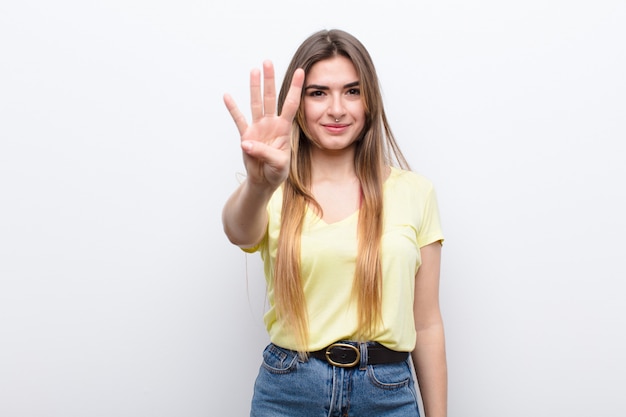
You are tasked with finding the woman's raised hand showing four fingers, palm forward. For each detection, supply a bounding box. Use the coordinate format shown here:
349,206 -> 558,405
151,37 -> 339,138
224,61 -> 304,188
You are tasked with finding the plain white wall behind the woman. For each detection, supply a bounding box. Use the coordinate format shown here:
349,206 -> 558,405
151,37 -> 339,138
0,0 -> 626,417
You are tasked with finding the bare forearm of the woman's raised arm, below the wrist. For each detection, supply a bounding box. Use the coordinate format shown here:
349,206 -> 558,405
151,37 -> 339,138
222,180 -> 274,247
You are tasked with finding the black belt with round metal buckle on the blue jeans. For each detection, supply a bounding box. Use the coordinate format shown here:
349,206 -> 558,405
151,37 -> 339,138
309,342 -> 409,368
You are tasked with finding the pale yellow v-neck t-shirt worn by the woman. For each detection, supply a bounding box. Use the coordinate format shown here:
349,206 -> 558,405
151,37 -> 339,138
247,168 -> 443,352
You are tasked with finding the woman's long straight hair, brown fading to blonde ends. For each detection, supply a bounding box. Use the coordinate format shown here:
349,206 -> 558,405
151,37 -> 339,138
274,29 -> 409,352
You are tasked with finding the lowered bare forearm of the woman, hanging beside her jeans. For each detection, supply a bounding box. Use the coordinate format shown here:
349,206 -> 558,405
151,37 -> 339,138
412,324 -> 448,417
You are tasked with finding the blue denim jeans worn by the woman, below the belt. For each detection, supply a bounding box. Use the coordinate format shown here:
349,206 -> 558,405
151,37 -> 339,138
250,344 -> 419,417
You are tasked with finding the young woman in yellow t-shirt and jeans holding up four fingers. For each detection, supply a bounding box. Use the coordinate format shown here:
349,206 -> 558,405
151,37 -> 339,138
223,30 -> 447,417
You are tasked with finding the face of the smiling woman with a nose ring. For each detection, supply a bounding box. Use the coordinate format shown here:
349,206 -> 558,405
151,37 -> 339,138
303,56 -> 365,151
